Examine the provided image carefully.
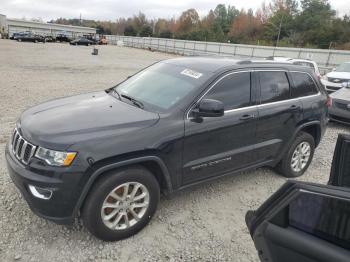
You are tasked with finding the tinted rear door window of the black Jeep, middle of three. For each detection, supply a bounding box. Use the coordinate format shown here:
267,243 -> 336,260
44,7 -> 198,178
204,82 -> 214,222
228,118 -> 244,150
260,72 -> 290,104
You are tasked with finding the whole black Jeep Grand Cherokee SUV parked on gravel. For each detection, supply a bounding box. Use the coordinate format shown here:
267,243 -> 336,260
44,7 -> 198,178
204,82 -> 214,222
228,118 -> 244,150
6,57 -> 330,241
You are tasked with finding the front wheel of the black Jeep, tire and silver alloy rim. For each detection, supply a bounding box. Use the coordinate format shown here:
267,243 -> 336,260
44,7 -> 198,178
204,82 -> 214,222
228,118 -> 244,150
82,166 -> 160,241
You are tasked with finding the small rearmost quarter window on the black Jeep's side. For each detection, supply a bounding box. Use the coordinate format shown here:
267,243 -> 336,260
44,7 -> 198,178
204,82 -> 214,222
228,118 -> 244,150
291,72 -> 318,97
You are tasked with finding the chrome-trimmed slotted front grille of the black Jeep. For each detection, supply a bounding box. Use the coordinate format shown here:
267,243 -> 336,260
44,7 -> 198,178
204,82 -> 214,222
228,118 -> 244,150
11,129 -> 36,164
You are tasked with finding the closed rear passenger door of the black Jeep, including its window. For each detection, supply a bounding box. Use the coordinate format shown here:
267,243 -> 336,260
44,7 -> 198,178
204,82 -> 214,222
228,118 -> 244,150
254,70 -> 303,163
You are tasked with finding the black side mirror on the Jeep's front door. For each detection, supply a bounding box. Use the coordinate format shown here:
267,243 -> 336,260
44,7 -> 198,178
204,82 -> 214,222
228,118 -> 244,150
192,99 -> 224,118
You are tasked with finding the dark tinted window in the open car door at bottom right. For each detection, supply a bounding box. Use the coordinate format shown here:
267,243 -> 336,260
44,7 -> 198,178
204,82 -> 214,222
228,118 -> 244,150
289,193 -> 350,249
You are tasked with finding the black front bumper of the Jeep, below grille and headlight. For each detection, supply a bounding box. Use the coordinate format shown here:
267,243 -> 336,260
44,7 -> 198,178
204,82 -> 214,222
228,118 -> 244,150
5,142 -> 87,224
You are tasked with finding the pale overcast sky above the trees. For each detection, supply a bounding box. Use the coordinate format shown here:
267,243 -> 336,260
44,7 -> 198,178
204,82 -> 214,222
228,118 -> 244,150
0,0 -> 350,21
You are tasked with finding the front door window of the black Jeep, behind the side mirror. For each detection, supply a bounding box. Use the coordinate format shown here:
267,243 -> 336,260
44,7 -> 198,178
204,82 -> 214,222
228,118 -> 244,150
205,72 -> 251,110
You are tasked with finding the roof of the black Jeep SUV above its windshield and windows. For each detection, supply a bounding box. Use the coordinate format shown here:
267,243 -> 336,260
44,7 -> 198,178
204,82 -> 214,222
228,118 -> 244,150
162,56 -> 312,73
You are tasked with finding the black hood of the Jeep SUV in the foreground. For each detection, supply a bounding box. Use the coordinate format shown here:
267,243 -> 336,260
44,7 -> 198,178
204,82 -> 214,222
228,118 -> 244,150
18,91 -> 159,150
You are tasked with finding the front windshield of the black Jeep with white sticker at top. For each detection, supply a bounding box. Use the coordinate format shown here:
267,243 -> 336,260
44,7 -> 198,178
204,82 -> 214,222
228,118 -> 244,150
115,62 -> 210,112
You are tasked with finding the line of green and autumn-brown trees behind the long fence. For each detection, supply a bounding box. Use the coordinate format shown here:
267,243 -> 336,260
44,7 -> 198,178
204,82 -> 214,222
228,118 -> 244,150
51,0 -> 350,49
